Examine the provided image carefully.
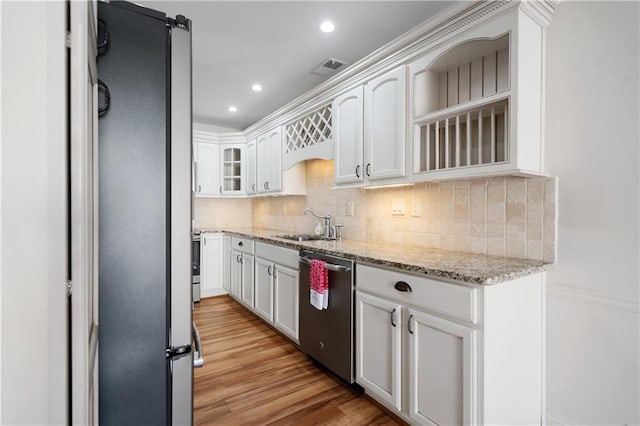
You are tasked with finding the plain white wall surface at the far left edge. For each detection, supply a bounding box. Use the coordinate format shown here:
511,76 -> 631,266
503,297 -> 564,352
0,1 -> 68,425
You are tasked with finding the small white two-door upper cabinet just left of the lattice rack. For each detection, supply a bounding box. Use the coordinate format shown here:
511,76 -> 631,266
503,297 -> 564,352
257,127 -> 282,194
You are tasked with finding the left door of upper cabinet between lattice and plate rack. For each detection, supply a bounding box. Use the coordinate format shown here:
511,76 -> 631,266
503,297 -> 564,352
333,86 -> 364,184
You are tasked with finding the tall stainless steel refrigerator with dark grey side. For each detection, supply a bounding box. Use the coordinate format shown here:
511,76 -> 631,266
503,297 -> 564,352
97,1 -> 195,425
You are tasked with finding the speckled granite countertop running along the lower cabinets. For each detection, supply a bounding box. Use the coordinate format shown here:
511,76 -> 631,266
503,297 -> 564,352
200,228 -> 554,285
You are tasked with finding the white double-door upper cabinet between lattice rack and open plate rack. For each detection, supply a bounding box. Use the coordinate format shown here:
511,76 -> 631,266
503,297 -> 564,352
333,66 -> 406,185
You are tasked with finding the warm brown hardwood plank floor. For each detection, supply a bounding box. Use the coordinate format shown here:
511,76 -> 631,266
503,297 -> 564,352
194,296 -> 401,425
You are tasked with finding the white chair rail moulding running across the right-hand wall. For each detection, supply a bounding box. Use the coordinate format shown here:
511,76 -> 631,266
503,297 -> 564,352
547,281 -> 640,314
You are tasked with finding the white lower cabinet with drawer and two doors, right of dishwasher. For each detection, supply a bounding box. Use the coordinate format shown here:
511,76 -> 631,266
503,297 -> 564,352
356,264 -> 543,424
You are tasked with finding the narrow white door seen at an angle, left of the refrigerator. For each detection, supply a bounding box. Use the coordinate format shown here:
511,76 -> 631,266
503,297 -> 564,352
69,1 -> 98,425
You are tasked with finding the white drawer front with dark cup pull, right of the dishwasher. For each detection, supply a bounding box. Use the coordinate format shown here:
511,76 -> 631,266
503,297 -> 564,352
356,265 -> 478,324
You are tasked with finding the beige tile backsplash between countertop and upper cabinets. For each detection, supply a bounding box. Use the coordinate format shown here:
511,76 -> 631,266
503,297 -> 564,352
195,160 -> 557,261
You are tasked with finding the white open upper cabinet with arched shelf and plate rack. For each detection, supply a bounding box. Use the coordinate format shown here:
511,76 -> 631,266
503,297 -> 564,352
409,7 -> 543,181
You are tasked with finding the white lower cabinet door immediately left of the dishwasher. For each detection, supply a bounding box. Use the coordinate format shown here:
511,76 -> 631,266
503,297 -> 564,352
273,265 -> 299,342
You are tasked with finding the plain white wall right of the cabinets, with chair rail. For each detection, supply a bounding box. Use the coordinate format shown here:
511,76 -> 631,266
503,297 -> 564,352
545,1 -> 640,424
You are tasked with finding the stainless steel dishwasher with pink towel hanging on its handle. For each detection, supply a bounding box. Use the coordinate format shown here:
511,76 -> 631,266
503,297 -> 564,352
299,250 -> 355,383
